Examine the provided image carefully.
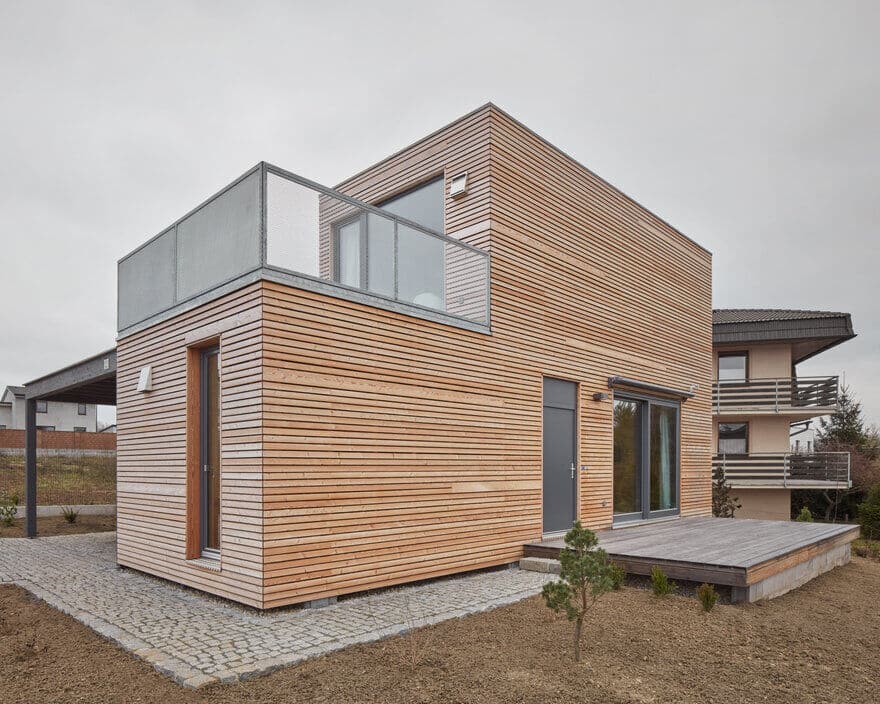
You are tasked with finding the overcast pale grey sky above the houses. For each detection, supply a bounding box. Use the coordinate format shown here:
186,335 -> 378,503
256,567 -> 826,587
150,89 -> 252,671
0,0 -> 880,422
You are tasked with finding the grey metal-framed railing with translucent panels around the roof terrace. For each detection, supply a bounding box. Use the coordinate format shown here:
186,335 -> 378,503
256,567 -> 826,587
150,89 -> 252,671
118,163 -> 490,334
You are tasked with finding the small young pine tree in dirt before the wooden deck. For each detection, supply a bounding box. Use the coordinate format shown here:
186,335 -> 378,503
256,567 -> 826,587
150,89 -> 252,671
541,521 -> 614,662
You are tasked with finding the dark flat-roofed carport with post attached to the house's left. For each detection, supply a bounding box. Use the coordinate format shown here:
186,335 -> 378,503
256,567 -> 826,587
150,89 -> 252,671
24,348 -> 116,538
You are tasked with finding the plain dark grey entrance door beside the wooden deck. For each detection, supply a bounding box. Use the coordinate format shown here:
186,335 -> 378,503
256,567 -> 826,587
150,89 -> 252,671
544,379 -> 577,533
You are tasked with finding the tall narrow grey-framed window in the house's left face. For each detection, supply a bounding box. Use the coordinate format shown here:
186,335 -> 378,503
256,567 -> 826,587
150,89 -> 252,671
199,347 -> 220,557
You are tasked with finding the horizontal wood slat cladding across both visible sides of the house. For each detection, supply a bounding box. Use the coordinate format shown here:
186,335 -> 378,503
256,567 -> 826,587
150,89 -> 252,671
119,106 -> 712,608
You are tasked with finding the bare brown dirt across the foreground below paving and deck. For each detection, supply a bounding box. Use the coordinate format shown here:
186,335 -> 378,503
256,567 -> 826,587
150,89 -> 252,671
0,558 -> 880,704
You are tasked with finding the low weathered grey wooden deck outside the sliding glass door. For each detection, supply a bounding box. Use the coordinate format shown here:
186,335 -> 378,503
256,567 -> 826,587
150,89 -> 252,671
525,518 -> 859,601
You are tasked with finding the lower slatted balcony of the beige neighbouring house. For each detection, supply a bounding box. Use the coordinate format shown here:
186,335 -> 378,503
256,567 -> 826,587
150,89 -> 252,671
712,452 -> 852,489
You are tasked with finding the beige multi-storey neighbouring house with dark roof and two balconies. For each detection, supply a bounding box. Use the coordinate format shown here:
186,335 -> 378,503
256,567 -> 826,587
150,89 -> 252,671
712,309 -> 855,520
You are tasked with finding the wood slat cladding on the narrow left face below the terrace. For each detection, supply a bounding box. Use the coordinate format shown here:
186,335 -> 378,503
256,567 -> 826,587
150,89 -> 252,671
116,284 -> 263,607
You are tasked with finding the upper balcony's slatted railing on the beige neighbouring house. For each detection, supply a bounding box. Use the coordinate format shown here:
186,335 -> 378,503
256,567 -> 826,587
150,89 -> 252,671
712,376 -> 838,414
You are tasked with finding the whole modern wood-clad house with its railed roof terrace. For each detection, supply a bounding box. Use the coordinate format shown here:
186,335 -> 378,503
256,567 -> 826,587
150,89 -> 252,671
116,105 -> 713,608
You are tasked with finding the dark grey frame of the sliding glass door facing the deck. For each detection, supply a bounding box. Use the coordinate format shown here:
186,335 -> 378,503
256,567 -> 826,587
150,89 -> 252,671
611,391 -> 681,526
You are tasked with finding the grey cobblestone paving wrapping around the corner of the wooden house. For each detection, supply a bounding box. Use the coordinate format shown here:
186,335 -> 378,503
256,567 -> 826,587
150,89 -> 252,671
0,533 -> 553,687
